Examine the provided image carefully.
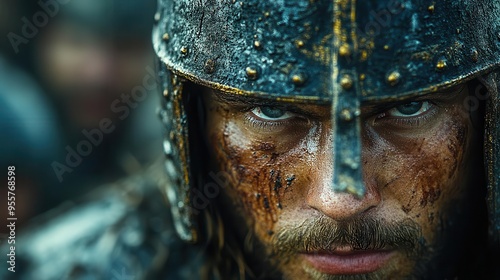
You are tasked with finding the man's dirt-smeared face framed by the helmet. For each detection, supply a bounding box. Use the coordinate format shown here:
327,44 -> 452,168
204,86 -> 479,279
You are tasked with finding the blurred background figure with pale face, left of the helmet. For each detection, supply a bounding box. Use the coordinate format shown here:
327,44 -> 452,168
28,0 -> 160,208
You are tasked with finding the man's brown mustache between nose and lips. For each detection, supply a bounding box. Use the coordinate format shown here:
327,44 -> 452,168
272,216 -> 422,257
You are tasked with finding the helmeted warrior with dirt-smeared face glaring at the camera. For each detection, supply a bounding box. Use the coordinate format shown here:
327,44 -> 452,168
4,0 -> 500,279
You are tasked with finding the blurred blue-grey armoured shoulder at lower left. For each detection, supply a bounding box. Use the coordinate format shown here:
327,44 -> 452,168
0,167 -> 206,280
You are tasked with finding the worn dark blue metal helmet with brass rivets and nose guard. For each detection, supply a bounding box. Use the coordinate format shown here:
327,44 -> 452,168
153,0 -> 500,245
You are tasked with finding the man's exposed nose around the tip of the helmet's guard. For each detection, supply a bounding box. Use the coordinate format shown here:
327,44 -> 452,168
306,152 -> 381,220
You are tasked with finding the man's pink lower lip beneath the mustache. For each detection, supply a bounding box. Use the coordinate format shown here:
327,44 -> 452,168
304,251 -> 392,275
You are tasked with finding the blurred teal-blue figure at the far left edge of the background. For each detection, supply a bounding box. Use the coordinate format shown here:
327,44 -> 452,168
0,0 -> 62,228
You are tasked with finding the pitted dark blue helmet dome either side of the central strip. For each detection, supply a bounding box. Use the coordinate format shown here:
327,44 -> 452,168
154,0 -> 500,103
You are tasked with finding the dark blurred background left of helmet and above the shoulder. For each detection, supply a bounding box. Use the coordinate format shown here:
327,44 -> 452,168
0,0 -> 162,232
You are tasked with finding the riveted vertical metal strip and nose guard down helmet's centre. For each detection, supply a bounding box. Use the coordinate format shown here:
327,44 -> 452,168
330,0 -> 365,197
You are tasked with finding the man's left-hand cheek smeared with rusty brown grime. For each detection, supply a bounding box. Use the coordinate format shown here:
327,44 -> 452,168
217,137 -> 301,238
